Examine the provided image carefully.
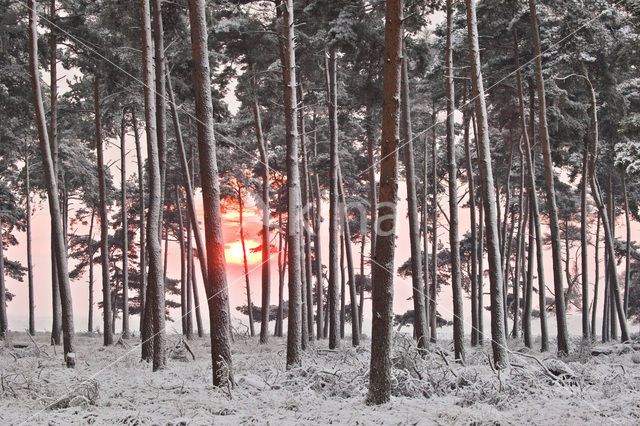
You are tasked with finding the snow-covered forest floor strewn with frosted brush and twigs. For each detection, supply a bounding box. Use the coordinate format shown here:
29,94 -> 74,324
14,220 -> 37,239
0,333 -> 640,425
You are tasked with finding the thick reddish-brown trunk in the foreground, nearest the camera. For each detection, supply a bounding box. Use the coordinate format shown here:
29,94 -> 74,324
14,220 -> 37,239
367,0 -> 403,404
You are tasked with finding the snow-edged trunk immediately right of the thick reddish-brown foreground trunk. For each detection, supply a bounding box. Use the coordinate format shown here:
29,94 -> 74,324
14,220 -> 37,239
400,41 -> 428,348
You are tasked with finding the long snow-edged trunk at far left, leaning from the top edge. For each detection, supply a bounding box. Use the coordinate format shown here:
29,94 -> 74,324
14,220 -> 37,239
27,0 -> 76,367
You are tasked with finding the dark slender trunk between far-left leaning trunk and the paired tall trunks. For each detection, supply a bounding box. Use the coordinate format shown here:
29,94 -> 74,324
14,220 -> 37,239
93,76 -> 113,346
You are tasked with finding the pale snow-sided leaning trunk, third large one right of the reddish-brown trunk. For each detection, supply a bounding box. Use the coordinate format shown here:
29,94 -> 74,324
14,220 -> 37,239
465,0 -> 508,368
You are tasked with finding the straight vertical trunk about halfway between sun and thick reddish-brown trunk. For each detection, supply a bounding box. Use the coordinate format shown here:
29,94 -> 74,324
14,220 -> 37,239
325,47 -> 340,349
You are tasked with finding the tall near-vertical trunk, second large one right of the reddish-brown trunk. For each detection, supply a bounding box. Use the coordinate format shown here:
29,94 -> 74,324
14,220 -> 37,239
447,0 -> 464,362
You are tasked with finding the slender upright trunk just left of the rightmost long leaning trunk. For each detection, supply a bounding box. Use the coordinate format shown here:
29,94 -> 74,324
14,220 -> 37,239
580,135 -> 592,341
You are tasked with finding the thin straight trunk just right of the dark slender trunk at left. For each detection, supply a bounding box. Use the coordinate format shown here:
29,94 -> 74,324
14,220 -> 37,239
120,110 -> 130,339
